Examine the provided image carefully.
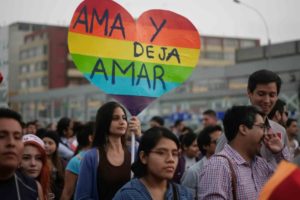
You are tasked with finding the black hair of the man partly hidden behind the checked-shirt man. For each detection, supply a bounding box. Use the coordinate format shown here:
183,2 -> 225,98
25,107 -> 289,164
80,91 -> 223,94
197,125 -> 222,155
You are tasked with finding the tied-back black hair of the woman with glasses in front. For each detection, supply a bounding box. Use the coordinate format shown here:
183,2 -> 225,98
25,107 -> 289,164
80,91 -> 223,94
131,127 -> 179,178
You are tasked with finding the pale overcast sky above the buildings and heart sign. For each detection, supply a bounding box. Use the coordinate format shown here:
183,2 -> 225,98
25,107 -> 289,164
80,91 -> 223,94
0,0 -> 300,44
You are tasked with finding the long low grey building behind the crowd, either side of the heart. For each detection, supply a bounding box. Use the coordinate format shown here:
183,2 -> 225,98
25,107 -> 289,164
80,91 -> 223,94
12,41 -> 300,124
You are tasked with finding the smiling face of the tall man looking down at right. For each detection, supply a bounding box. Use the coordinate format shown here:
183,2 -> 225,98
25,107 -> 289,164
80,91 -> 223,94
248,82 -> 278,115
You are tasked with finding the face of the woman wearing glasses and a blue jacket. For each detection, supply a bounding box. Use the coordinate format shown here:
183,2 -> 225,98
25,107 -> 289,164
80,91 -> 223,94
140,138 -> 179,180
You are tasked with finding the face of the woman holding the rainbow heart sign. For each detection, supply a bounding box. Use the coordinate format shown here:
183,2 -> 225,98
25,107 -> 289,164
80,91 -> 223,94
109,107 -> 127,136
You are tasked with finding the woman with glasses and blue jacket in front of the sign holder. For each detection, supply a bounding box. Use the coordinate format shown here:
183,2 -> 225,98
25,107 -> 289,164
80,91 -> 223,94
114,127 -> 192,200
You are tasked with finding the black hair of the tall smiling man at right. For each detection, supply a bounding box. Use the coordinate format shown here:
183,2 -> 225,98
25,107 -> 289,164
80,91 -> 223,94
248,69 -> 281,95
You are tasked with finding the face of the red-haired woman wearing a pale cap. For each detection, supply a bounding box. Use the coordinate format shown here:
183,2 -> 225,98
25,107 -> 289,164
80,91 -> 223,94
21,145 -> 43,178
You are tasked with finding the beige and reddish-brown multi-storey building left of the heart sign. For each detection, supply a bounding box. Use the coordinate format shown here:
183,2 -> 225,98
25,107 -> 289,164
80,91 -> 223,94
18,26 -> 87,94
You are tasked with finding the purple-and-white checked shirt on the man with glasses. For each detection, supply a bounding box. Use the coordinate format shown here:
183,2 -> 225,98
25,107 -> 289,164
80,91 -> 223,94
197,144 -> 289,200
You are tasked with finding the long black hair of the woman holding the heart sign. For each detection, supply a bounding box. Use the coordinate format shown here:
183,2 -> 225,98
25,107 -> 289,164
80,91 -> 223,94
92,101 -> 127,148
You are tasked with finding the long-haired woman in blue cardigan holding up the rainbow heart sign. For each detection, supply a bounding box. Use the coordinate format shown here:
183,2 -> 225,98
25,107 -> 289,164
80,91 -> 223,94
75,102 -> 141,200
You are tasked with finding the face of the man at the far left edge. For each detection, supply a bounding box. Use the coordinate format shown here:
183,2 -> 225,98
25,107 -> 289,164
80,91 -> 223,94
0,118 -> 24,169
